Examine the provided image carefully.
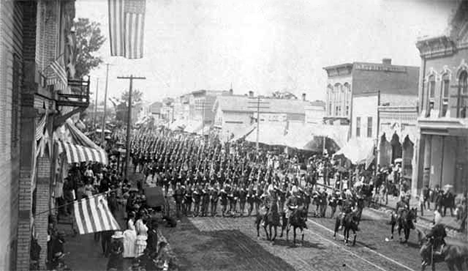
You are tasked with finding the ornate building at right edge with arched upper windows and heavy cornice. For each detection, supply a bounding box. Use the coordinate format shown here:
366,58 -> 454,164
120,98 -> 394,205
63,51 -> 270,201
413,1 -> 468,196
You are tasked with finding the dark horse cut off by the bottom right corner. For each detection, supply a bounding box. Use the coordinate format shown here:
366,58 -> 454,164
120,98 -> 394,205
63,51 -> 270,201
416,229 -> 468,271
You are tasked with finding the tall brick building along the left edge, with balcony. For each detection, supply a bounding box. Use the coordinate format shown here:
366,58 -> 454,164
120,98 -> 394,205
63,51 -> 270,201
0,0 -> 89,270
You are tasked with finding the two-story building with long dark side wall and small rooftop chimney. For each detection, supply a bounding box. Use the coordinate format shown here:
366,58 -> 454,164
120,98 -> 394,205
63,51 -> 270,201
324,58 -> 419,166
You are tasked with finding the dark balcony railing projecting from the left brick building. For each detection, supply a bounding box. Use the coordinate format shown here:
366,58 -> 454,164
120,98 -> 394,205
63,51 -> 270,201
57,78 -> 90,108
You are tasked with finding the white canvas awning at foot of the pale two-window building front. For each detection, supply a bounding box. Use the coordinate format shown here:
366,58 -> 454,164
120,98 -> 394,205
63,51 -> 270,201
334,138 -> 375,164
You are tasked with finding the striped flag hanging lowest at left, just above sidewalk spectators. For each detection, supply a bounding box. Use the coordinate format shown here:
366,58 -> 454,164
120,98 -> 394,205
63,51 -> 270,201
74,194 -> 120,234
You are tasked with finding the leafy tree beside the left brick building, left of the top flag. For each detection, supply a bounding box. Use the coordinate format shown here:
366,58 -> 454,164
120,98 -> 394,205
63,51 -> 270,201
75,18 -> 106,78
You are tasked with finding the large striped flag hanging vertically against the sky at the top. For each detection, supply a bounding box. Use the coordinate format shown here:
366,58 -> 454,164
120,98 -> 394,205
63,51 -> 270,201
109,0 -> 146,59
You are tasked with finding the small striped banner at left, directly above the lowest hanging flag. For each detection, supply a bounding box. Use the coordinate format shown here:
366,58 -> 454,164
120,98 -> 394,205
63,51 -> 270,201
60,141 -> 108,165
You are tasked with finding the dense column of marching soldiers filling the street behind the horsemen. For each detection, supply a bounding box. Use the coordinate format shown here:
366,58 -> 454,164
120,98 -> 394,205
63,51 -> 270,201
124,131 -> 358,220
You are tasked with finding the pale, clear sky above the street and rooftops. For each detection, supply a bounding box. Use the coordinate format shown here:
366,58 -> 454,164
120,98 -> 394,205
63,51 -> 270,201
76,0 -> 456,105
